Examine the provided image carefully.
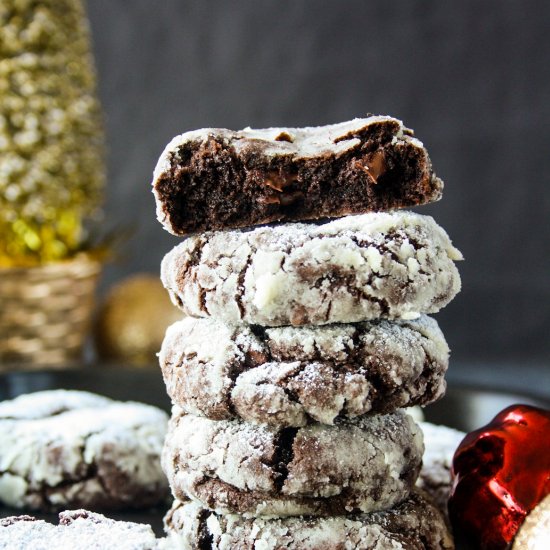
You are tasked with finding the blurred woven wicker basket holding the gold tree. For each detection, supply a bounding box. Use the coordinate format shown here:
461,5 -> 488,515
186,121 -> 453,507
0,255 -> 101,370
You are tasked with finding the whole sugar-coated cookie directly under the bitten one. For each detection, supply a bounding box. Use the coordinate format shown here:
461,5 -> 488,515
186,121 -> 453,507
161,212 -> 462,326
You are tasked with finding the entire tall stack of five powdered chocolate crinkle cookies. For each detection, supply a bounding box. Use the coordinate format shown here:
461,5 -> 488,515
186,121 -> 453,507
153,117 -> 461,549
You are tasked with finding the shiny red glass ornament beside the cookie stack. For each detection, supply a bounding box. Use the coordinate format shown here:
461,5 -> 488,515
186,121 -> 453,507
449,405 -> 550,550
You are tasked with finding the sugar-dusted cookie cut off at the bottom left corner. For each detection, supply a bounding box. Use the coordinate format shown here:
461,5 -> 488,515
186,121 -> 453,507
0,510 -> 166,550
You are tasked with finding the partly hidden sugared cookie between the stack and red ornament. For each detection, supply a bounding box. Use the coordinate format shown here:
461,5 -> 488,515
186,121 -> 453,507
416,422 -> 466,516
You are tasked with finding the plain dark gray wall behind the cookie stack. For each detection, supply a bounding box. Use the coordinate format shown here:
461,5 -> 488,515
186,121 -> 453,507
88,0 -> 550,369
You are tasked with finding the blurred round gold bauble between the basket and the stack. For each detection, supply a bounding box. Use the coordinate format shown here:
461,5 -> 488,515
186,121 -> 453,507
96,274 -> 183,366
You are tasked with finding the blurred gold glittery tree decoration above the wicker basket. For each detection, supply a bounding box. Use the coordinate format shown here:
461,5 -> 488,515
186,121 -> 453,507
0,0 -> 105,267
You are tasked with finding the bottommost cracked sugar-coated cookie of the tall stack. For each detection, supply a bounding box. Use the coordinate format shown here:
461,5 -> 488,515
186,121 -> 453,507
165,492 -> 454,550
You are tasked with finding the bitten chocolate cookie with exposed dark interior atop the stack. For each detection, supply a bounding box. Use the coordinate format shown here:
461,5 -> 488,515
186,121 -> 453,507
153,116 -> 443,235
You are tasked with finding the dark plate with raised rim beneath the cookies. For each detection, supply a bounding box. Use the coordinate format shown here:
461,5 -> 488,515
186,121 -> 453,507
0,367 -> 550,550
